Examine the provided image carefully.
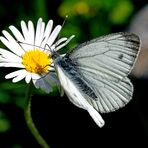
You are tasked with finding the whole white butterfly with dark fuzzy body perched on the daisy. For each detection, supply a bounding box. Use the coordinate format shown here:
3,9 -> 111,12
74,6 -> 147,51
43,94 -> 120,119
53,32 -> 140,127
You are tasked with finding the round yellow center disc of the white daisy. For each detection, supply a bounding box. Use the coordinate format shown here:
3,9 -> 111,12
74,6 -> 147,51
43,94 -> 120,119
22,49 -> 52,74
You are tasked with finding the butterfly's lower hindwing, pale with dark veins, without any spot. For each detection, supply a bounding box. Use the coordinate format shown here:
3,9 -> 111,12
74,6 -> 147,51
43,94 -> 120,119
80,75 -> 133,113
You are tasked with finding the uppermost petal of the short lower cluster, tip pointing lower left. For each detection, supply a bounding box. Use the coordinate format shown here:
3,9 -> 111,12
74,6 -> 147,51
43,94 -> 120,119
5,69 -> 27,79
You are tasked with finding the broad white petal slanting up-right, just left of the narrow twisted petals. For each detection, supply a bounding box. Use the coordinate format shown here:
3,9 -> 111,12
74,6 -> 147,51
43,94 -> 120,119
47,25 -> 61,46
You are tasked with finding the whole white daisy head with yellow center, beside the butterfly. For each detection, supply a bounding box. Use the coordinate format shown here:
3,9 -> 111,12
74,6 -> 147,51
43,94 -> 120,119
0,18 -> 74,92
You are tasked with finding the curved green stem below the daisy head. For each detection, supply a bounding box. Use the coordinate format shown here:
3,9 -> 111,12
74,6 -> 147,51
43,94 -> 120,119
24,83 -> 50,148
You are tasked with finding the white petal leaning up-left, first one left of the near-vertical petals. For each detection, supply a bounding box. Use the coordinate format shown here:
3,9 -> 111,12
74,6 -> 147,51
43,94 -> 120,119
9,26 -> 25,43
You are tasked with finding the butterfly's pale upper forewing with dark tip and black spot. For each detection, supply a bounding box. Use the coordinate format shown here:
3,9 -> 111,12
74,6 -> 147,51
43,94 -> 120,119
66,33 -> 140,81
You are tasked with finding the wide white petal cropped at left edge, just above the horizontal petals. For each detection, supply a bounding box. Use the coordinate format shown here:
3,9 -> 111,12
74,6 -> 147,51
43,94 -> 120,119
0,48 -> 22,63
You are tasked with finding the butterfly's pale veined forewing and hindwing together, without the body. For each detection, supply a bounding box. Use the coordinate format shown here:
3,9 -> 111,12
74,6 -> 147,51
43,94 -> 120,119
66,33 -> 140,113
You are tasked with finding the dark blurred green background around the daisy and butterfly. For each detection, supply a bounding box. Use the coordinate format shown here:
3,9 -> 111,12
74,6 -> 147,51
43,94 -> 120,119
0,0 -> 148,148
